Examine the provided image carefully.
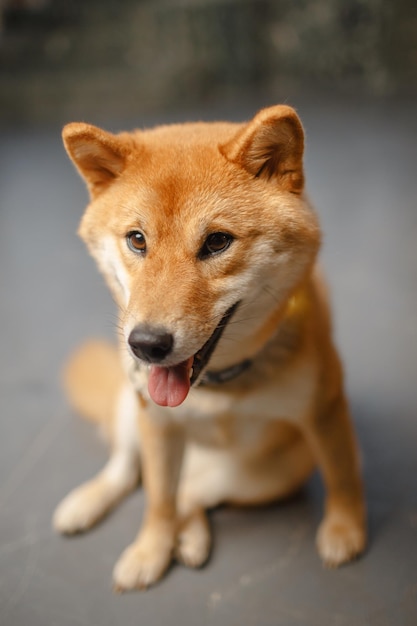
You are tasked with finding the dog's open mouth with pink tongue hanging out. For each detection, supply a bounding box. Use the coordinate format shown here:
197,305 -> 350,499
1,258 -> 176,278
148,302 -> 239,407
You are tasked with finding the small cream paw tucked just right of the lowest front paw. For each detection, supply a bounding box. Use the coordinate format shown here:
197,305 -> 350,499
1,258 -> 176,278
175,511 -> 211,567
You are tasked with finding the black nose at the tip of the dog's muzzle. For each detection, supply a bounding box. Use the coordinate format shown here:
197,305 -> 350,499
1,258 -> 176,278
128,324 -> 174,363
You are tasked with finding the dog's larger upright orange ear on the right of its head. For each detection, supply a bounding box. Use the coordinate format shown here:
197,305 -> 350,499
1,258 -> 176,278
220,105 -> 304,194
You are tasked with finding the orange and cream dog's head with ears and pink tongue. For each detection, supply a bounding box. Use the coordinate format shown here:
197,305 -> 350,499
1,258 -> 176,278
63,106 -> 320,406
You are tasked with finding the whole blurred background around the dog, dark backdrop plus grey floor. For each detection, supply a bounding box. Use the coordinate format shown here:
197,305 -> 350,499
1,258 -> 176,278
0,0 -> 417,626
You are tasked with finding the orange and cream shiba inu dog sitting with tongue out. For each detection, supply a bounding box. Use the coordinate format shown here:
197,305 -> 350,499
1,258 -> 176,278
54,106 -> 366,590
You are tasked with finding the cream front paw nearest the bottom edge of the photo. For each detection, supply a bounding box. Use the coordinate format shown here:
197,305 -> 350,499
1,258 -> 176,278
113,541 -> 172,592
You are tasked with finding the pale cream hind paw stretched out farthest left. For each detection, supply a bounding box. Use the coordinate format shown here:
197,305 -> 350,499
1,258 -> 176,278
52,483 -> 107,535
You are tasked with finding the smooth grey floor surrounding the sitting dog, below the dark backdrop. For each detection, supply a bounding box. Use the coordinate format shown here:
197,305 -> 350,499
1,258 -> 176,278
0,95 -> 417,626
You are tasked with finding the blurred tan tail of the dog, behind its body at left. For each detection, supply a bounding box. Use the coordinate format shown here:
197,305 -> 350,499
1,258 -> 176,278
63,340 -> 125,431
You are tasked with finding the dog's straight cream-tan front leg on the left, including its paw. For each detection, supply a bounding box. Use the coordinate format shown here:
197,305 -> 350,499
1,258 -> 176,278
113,404 -> 185,591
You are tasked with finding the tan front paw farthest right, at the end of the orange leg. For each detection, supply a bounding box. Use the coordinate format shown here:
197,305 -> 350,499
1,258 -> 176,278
317,516 -> 366,567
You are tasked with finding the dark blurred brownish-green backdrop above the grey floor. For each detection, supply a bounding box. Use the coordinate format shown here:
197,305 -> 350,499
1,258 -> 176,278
0,0 -> 417,121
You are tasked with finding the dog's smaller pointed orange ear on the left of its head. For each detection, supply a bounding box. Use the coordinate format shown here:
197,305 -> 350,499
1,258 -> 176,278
62,122 -> 129,197
